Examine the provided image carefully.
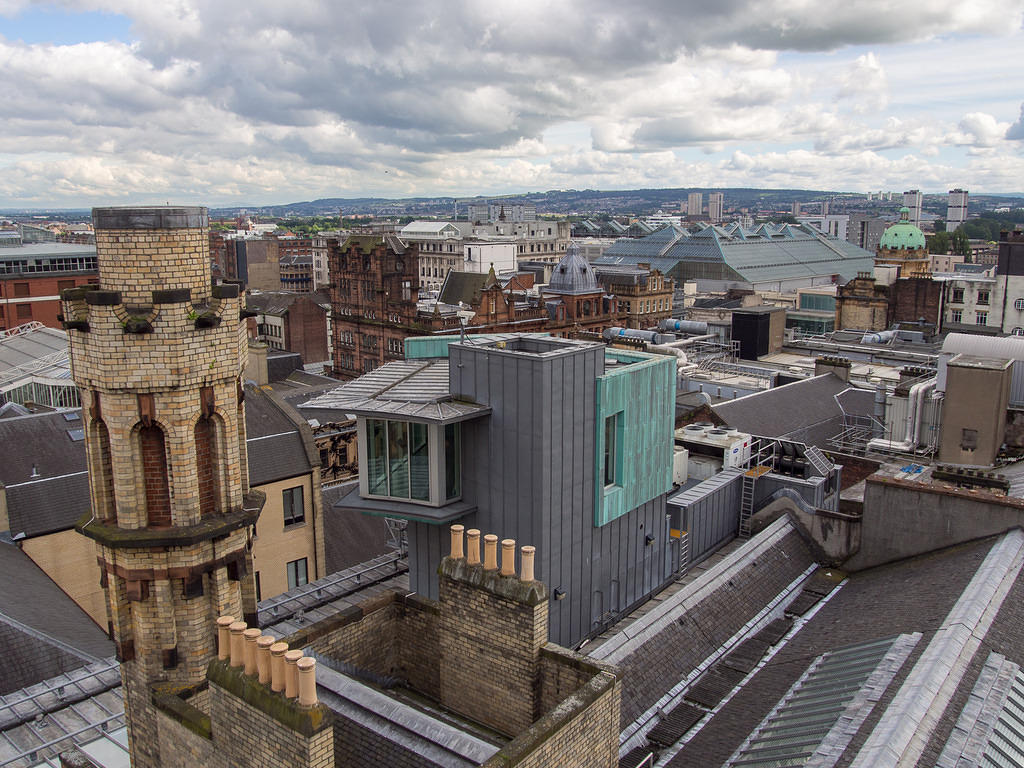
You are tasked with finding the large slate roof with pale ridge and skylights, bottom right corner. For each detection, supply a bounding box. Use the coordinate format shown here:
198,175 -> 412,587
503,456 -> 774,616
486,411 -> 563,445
668,531 -> 1011,768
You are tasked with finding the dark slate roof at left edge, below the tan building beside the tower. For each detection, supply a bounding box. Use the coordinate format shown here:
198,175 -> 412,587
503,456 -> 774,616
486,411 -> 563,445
0,543 -> 114,693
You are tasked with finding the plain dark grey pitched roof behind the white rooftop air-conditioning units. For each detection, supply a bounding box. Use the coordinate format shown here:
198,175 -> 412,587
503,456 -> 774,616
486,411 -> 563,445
712,373 -> 873,447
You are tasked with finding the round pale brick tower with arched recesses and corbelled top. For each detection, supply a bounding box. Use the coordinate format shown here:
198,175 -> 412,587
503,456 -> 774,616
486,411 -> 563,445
61,207 -> 263,768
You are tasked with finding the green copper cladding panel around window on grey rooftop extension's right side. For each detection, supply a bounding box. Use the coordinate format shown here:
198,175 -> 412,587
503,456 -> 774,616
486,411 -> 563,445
594,349 -> 676,526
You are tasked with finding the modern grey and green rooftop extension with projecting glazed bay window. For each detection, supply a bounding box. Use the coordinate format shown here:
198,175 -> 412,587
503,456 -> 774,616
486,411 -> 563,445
303,335 -> 679,645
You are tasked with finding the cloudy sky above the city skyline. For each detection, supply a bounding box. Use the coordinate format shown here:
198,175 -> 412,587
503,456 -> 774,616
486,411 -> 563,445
0,0 -> 1024,207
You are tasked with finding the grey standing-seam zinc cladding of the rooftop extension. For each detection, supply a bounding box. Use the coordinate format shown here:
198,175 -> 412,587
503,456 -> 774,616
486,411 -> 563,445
409,339 -> 669,645
